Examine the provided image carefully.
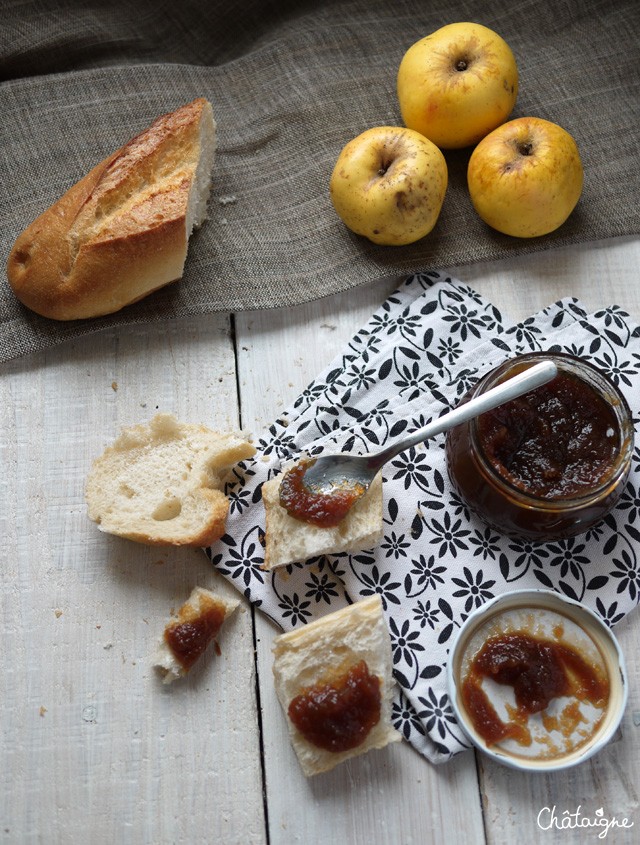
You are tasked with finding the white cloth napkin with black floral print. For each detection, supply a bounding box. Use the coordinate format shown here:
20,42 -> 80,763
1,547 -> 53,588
207,272 -> 640,762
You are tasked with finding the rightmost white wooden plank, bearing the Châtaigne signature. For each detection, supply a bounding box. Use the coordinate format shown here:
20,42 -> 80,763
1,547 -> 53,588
458,239 -> 640,845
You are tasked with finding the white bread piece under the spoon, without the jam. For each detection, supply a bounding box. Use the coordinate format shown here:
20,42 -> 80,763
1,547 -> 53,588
262,464 -> 384,569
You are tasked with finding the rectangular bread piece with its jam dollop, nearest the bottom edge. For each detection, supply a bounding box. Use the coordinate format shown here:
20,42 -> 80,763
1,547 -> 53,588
273,595 -> 401,777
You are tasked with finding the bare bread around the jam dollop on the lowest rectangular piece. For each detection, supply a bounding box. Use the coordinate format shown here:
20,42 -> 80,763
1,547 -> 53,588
273,595 -> 402,777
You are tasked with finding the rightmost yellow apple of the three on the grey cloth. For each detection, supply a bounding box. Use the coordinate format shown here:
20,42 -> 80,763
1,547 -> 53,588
467,117 -> 583,238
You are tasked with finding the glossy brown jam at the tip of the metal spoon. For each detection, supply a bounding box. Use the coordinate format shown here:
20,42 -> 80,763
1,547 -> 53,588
279,460 -> 365,528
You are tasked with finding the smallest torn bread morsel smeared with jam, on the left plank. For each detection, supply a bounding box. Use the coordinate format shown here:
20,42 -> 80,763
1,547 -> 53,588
154,587 -> 240,684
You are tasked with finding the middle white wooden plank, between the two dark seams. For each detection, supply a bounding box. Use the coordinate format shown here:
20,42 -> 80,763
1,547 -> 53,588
236,280 -> 484,845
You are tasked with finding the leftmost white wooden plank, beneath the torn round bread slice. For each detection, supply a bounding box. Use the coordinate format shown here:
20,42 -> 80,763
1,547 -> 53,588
0,316 -> 265,845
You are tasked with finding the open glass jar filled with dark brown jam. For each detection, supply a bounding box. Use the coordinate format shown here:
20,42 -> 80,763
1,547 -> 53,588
446,352 -> 634,541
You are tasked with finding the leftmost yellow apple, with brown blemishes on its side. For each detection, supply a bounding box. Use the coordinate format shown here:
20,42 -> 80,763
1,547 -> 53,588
329,126 -> 448,246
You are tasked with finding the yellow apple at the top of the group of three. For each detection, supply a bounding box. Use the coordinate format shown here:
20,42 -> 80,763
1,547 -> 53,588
397,22 -> 518,149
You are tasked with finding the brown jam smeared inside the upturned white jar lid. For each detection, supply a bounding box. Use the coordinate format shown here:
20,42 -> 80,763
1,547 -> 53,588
462,631 -> 609,745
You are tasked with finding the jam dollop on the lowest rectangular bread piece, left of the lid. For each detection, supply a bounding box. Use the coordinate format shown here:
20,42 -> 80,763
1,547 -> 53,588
288,660 -> 381,752
